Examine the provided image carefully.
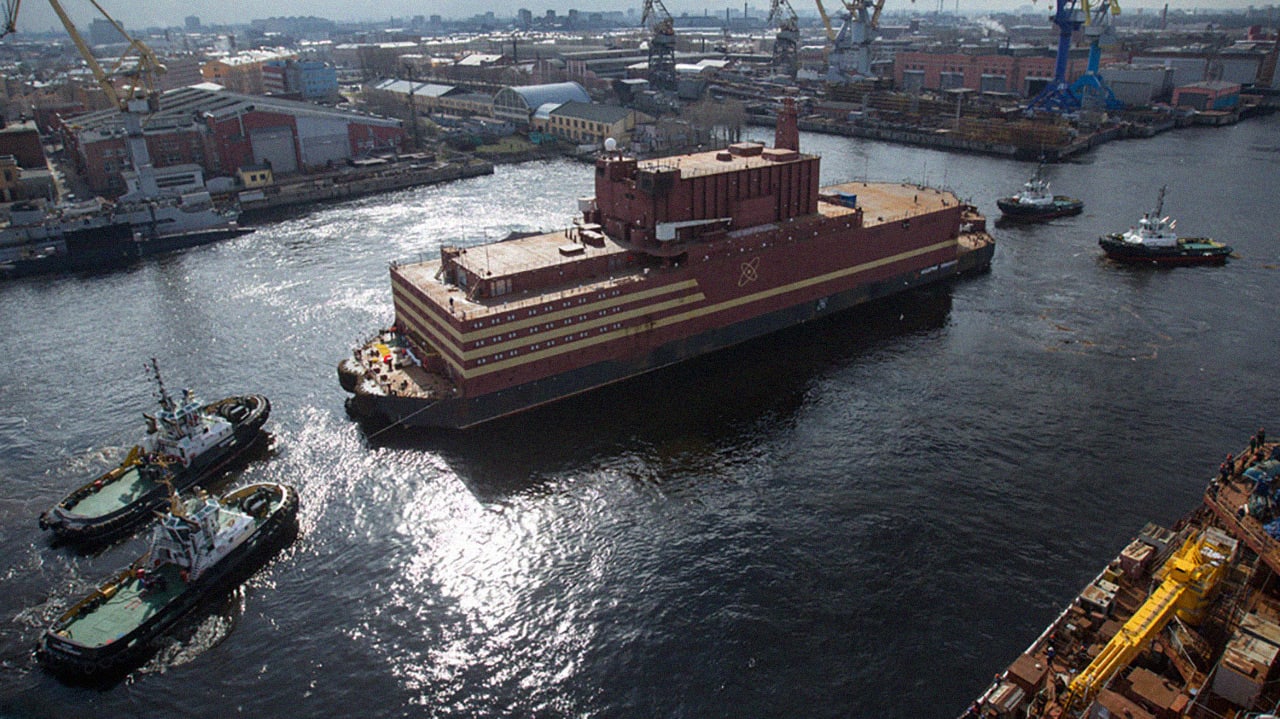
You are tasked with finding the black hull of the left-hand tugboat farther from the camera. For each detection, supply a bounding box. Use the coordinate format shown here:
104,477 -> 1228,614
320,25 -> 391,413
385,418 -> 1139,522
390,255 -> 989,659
40,395 -> 271,545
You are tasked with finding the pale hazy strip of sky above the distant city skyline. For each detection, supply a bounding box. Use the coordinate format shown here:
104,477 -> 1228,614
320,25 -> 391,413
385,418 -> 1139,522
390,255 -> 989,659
7,0 -> 1275,32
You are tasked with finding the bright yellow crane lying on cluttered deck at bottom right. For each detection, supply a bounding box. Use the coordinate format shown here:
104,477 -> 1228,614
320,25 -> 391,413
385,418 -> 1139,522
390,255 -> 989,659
1062,530 -> 1235,715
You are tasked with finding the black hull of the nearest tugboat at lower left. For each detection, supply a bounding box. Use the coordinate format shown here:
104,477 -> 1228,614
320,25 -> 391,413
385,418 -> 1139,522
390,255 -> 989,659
36,486 -> 298,682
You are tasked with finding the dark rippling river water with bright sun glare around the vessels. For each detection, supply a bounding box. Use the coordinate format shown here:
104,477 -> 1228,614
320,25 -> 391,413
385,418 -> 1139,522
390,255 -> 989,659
0,116 -> 1280,718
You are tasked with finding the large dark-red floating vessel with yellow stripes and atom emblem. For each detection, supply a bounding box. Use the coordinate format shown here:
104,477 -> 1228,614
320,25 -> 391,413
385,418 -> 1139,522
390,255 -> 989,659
338,101 -> 995,429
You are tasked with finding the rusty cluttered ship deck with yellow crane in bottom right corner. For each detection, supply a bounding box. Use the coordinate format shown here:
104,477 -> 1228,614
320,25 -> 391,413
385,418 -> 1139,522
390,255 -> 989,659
961,430 -> 1280,719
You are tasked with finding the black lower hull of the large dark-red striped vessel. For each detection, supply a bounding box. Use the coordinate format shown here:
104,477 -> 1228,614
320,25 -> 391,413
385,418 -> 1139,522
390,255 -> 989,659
338,244 -> 995,429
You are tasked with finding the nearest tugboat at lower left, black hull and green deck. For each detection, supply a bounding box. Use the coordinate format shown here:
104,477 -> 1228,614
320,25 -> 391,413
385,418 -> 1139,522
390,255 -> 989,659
36,482 -> 298,681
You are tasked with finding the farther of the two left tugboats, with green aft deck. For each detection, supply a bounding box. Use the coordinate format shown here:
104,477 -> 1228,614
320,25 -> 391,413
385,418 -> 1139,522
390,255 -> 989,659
40,358 -> 271,544
